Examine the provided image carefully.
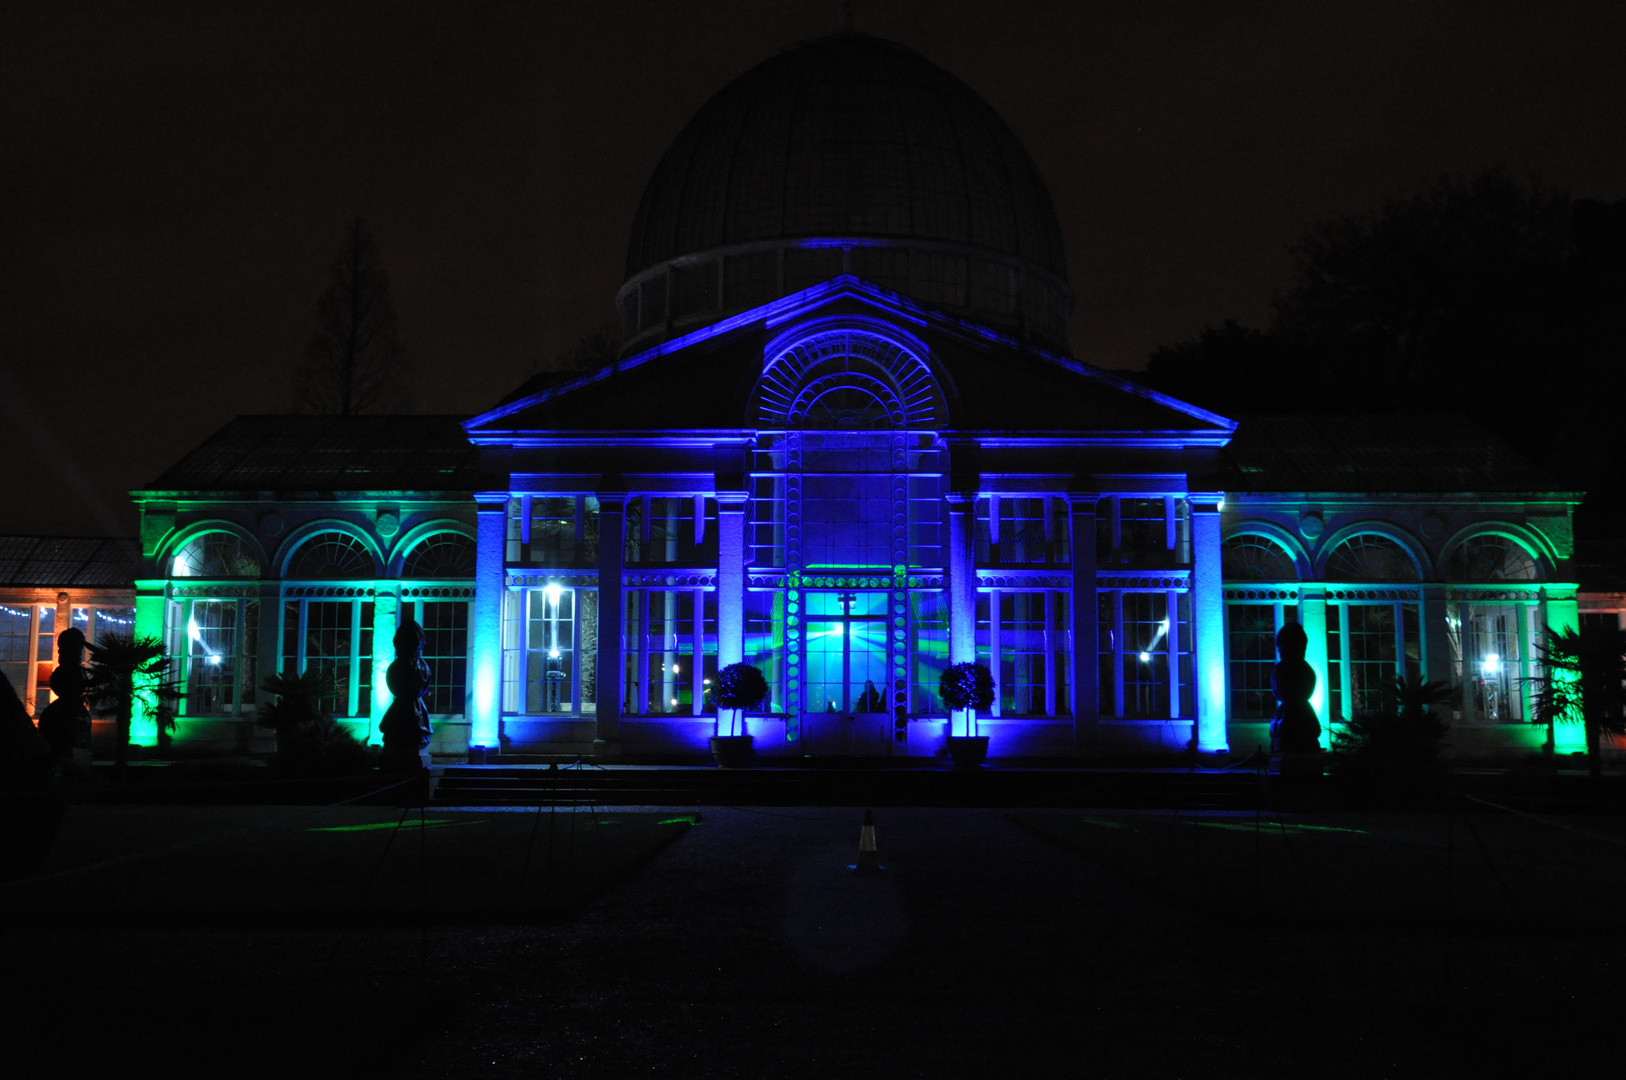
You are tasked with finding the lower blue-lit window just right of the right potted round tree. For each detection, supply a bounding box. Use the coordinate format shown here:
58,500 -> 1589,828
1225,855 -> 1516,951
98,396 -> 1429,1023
977,589 -> 1072,716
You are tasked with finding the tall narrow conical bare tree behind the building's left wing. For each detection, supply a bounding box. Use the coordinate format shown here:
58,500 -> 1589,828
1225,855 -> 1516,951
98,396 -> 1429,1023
294,218 -> 411,416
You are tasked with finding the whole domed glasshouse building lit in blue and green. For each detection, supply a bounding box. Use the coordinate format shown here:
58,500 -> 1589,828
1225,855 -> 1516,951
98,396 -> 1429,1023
135,33 -> 1579,760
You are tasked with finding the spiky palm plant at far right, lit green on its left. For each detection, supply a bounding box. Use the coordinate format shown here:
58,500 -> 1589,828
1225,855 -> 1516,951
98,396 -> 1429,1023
1525,625 -> 1626,776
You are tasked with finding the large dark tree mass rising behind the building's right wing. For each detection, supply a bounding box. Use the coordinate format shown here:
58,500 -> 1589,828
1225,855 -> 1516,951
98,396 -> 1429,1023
1143,169 -> 1626,535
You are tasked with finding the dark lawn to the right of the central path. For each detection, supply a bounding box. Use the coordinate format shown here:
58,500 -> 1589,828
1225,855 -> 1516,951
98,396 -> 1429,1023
1008,810 -> 1626,938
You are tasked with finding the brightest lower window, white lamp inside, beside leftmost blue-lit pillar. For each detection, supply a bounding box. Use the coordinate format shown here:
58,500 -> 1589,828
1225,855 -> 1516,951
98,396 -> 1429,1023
502,584 -> 598,716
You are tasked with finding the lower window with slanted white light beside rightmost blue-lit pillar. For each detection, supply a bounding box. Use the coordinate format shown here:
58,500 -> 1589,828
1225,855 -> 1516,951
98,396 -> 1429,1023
1096,589 -> 1197,719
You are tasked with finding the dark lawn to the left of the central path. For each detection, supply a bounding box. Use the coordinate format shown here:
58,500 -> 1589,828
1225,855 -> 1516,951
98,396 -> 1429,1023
0,807 -> 698,930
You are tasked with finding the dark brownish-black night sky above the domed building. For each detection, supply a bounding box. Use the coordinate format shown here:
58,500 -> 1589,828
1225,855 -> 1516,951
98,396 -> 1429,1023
0,0 -> 1626,533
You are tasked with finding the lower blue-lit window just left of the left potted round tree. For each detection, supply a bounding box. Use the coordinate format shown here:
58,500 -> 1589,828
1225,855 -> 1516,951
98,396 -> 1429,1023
621,589 -> 717,716
